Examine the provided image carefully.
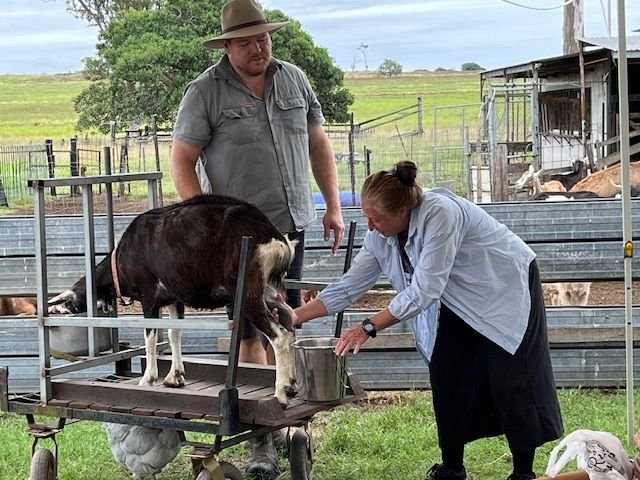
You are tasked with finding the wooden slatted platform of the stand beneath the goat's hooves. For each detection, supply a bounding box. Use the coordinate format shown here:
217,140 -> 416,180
10,356 -> 366,428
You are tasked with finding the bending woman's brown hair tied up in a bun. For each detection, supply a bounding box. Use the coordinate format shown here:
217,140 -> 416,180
360,160 -> 422,213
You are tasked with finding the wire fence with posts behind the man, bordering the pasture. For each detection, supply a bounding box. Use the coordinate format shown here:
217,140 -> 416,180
0,99 -> 479,209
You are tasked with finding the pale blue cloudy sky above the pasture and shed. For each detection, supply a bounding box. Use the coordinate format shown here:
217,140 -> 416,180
0,0 -> 640,73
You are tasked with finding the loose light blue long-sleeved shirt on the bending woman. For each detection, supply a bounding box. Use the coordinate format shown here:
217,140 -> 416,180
318,188 -> 535,360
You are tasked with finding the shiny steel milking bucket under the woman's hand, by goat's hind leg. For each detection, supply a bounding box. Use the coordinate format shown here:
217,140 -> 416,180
293,337 -> 347,403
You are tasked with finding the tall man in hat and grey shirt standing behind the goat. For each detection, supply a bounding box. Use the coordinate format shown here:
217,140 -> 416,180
170,0 -> 344,478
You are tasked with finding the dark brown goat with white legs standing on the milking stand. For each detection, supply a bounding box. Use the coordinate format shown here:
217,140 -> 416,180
49,195 -> 295,405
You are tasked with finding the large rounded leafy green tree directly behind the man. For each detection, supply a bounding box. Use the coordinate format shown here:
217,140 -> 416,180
75,0 -> 353,131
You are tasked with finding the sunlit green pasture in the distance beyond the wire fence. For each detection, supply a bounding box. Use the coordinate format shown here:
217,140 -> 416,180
0,71 -> 480,145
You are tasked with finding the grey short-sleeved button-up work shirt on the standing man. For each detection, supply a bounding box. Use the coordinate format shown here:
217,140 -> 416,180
173,55 -> 324,232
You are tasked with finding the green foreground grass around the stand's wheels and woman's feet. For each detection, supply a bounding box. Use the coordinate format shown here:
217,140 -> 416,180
0,389 -> 638,480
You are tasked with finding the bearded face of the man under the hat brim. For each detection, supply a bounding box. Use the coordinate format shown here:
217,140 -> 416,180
224,33 -> 271,77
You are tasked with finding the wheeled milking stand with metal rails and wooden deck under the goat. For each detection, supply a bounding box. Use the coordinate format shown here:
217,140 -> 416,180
0,171 -> 365,480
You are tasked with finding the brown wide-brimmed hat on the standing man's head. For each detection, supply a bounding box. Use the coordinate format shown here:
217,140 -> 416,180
202,0 -> 289,48
